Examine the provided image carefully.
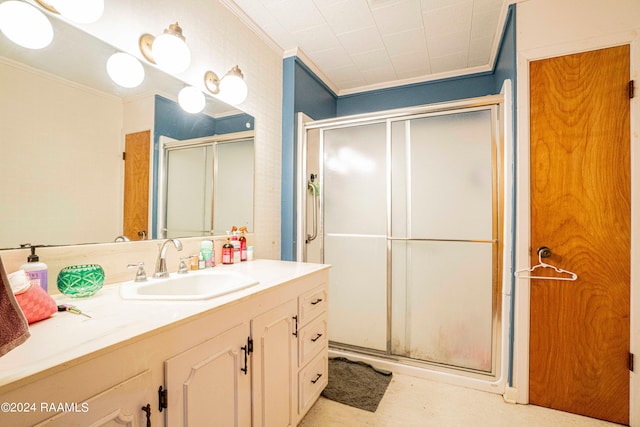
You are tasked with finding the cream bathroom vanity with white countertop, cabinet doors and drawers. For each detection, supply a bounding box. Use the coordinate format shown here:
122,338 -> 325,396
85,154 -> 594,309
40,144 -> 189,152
0,260 -> 329,427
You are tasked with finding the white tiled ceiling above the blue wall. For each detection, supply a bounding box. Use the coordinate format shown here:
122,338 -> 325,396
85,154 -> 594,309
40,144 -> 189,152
228,0 -> 510,94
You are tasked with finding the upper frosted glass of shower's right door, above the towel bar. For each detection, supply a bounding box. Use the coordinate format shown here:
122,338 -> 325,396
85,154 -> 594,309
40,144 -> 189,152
408,110 -> 493,240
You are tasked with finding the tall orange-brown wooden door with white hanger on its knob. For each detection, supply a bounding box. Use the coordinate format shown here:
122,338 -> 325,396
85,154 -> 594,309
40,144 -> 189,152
529,46 -> 631,424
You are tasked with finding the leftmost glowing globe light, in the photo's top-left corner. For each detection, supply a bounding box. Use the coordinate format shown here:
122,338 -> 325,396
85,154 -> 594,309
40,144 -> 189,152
0,0 -> 53,49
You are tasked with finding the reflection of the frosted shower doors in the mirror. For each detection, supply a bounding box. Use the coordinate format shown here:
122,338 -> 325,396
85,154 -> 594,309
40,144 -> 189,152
157,131 -> 255,238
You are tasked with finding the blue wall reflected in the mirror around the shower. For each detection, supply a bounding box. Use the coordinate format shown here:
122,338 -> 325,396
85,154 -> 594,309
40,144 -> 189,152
151,95 -> 254,239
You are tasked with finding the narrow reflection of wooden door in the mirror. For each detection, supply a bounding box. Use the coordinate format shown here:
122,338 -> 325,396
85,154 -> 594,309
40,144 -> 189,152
122,130 -> 151,240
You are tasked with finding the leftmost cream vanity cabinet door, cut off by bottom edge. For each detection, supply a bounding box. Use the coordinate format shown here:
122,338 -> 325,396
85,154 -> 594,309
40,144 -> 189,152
35,371 -> 158,427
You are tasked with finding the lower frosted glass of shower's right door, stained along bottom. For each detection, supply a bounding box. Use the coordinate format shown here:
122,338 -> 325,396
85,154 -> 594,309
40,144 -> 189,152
392,241 -> 493,372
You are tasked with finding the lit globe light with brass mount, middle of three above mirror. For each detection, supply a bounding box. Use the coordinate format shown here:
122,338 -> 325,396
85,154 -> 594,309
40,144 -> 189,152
138,22 -> 191,74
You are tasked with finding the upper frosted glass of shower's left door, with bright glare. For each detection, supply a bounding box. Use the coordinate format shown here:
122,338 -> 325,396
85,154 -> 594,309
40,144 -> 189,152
320,123 -> 387,235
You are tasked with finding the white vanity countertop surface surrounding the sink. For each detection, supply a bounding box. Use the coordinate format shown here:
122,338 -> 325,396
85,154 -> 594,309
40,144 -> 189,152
0,260 -> 328,389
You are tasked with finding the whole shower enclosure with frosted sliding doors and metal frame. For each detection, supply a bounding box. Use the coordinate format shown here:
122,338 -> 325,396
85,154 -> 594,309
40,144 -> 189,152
298,96 -> 503,377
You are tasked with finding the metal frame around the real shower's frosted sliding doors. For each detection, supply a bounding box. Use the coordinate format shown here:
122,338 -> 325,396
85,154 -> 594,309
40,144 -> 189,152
296,91 -> 510,379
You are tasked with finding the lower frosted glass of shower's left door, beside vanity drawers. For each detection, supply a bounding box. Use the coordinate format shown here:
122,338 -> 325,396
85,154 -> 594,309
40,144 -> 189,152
324,235 -> 387,350
